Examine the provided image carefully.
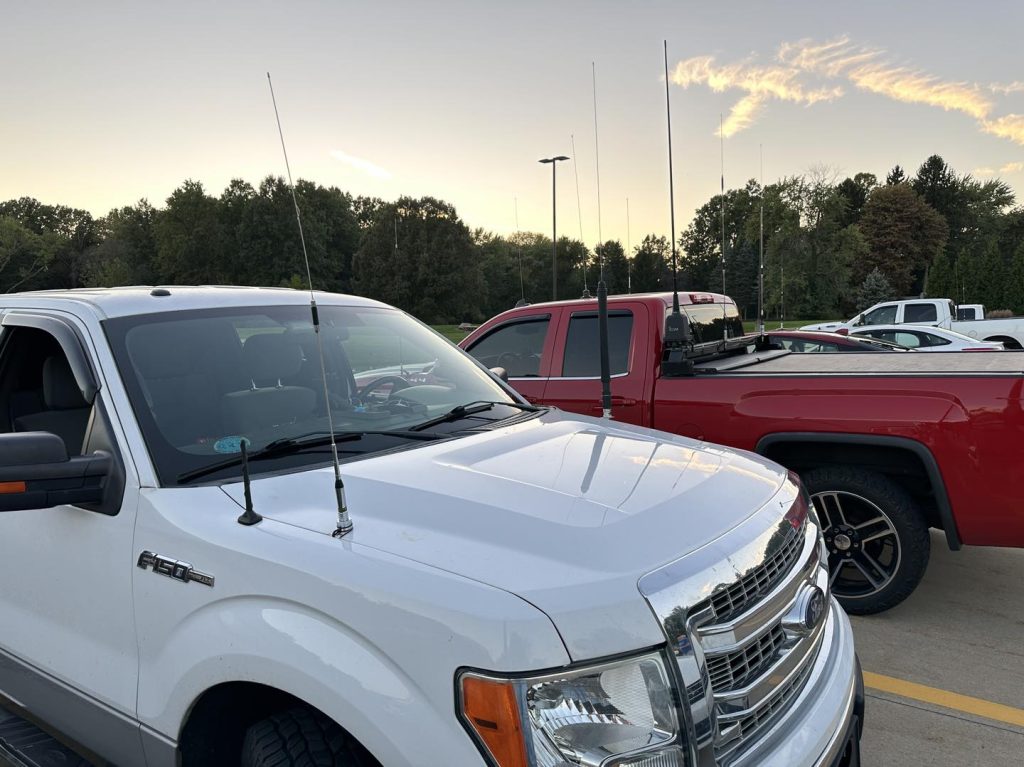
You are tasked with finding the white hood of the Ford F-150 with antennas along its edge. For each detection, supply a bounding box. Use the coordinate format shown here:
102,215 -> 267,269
223,411 -> 786,659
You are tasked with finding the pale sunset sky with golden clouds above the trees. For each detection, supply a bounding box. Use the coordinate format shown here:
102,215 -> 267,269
0,0 -> 1024,247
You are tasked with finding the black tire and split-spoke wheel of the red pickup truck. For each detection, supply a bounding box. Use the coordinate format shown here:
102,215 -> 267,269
802,466 -> 931,615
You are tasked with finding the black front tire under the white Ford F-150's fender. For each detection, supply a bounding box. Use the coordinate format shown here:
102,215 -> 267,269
242,708 -> 376,767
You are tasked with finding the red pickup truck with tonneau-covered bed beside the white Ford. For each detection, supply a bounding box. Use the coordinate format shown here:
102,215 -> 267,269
460,293 -> 1024,613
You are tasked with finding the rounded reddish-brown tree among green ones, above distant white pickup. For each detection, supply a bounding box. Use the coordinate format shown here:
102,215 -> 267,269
855,184 -> 946,296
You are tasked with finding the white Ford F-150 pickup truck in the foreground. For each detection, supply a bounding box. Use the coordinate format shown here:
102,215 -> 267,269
0,288 -> 863,767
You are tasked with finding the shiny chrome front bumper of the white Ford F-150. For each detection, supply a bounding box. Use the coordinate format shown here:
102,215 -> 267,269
733,599 -> 864,767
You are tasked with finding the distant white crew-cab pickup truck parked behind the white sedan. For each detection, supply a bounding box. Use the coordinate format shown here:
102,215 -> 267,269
801,298 -> 1024,349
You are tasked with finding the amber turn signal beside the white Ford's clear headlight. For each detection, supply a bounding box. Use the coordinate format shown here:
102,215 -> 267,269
462,676 -> 528,767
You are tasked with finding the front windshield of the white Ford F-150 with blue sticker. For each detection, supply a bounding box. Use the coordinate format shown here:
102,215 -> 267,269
104,305 -> 518,484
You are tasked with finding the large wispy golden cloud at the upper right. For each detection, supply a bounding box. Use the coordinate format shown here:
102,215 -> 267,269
672,37 -> 1024,143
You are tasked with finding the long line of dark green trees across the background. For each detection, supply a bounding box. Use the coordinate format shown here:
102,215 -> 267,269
0,157 -> 1024,324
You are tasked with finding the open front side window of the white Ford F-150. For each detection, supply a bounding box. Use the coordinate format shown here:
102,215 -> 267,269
0,328 -> 92,456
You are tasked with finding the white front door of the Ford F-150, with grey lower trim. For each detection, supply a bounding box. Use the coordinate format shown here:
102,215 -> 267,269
0,311 -> 142,764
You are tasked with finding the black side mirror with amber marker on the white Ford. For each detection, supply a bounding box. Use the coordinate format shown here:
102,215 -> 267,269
0,431 -> 113,512
